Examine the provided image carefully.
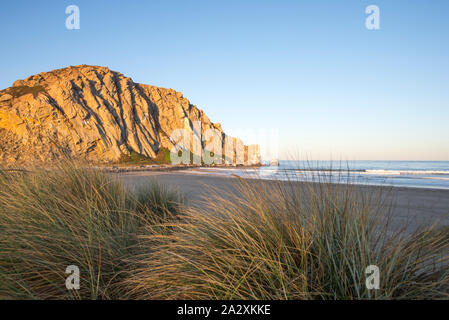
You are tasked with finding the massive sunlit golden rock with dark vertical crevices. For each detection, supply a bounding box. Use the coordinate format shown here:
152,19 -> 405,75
0,65 -> 260,164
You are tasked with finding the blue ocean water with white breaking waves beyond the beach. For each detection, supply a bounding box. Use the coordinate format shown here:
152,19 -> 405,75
187,160 -> 449,190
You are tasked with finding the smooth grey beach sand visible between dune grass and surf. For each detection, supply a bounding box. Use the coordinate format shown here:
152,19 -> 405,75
118,172 -> 449,231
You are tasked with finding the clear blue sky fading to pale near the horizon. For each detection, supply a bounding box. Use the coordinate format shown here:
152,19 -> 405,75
0,0 -> 449,160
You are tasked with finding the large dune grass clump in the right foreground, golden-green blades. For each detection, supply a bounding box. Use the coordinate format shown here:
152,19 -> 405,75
127,174 -> 449,299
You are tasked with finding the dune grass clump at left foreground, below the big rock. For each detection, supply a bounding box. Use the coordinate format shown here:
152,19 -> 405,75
0,163 -> 179,299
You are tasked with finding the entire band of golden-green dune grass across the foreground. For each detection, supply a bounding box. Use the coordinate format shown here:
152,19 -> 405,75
0,164 -> 449,299
